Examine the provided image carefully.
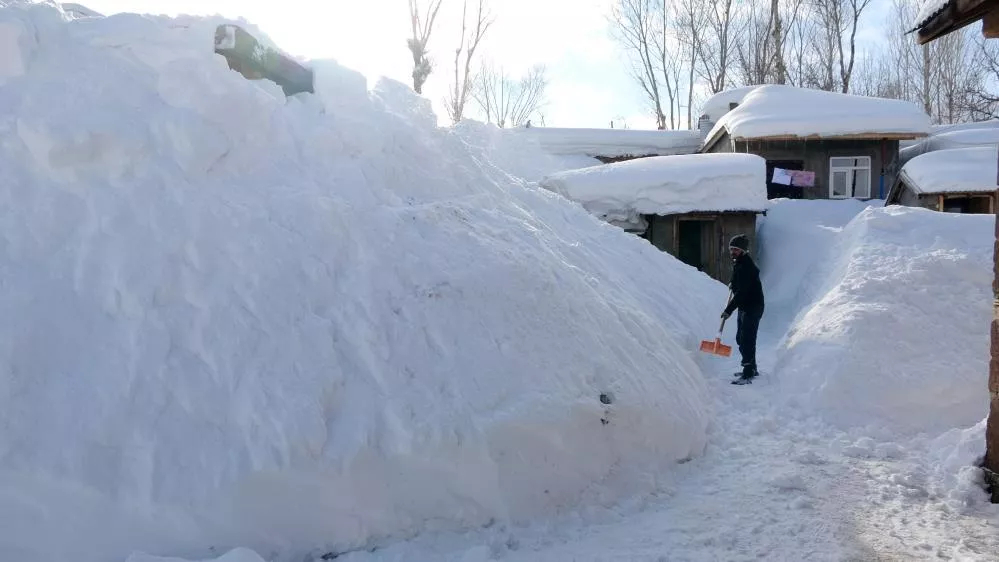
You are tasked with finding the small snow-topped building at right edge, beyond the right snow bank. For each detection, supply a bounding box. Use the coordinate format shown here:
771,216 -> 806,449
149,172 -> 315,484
885,146 -> 999,214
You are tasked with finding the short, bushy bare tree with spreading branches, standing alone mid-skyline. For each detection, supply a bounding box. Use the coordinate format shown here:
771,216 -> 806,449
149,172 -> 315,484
472,65 -> 548,127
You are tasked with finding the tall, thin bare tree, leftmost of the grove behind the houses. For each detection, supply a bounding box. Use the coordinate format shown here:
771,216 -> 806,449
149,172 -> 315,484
611,0 -> 666,129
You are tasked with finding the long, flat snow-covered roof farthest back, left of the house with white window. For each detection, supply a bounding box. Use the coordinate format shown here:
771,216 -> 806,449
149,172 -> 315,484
517,127 -> 701,158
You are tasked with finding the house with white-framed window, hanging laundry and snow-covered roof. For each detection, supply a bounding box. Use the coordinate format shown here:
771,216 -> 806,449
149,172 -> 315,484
701,84 -> 931,199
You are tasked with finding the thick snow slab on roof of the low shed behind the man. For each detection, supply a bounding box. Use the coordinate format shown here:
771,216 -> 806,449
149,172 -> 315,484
540,154 -> 767,222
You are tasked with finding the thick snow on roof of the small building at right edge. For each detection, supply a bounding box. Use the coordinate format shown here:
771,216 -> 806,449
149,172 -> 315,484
900,146 -> 999,194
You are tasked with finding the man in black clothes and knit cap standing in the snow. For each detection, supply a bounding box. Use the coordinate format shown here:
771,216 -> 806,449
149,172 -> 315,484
722,234 -> 763,384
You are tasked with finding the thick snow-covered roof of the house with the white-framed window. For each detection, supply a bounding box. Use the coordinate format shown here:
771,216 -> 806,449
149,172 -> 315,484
705,85 -> 931,146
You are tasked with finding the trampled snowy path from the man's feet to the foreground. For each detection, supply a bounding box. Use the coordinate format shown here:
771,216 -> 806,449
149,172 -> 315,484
338,326 -> 999,562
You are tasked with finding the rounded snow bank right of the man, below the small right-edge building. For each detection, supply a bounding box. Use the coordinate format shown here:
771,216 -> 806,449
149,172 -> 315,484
768,207 -> 994,431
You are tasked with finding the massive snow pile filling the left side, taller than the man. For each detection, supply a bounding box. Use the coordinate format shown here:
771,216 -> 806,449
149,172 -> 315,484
0,4 -> 725,562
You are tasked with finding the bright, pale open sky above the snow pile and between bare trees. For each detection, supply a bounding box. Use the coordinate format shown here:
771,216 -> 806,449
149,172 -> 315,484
80,0 -> 891,128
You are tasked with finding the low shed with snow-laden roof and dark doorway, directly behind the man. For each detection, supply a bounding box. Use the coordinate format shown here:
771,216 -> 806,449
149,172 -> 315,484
539,154 -> 767,283
